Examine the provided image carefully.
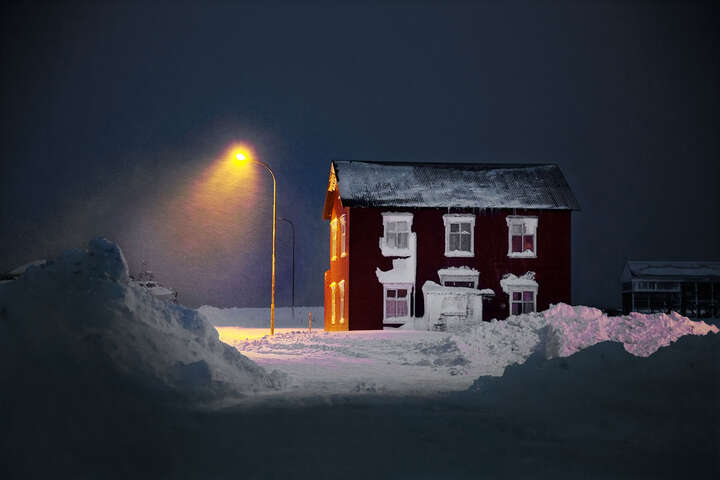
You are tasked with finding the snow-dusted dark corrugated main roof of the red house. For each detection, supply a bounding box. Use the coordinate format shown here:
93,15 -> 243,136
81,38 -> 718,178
333,160 -> 579,210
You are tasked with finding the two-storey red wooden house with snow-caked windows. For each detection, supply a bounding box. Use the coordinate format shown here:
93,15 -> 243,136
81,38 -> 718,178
323,161 -> 578,330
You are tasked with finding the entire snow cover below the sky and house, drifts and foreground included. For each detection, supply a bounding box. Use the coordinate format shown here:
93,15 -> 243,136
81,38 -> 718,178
0,239 -> 720,480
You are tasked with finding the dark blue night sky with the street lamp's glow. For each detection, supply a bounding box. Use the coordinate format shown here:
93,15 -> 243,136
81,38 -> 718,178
0,2 -> 720,306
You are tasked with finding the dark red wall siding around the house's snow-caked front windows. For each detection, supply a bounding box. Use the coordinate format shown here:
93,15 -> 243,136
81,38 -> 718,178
346,206 -> 571,330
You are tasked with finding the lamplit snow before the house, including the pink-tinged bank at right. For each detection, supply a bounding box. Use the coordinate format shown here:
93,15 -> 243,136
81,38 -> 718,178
205,304 -> 718,395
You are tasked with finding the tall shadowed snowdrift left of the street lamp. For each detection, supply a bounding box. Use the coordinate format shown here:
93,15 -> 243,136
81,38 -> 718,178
0,238 -> 286,400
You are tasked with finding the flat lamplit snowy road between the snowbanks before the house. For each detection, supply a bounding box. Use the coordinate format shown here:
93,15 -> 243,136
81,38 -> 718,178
217,327 -> 478,394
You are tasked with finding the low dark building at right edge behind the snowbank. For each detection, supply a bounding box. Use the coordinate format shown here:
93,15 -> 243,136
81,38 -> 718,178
620,261 -> 720,318
